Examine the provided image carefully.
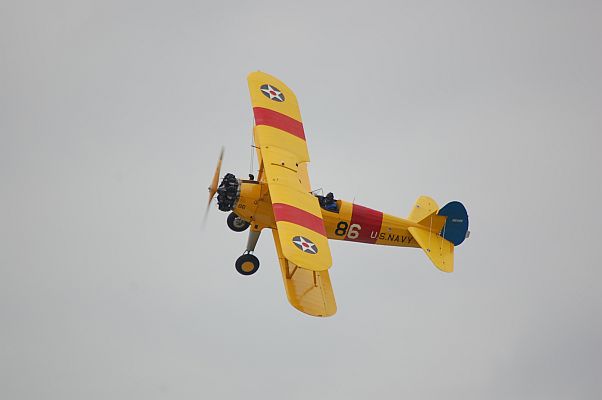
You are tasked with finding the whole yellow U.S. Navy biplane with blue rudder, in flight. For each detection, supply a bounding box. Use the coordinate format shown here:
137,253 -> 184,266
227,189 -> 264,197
207,72 -> 469,317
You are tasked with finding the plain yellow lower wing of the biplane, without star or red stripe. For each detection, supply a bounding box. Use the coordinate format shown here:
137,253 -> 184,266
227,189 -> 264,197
272,230 -> 337,317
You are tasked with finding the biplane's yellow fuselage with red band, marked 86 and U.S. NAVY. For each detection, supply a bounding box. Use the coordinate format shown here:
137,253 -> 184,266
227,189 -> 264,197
233,180 -> 424,248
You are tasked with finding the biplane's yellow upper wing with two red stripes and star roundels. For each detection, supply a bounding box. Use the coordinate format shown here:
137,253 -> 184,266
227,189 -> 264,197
248,72 -> 332,271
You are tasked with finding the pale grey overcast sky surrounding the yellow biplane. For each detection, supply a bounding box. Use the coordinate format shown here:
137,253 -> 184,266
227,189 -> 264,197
0,0 -> 602,399
